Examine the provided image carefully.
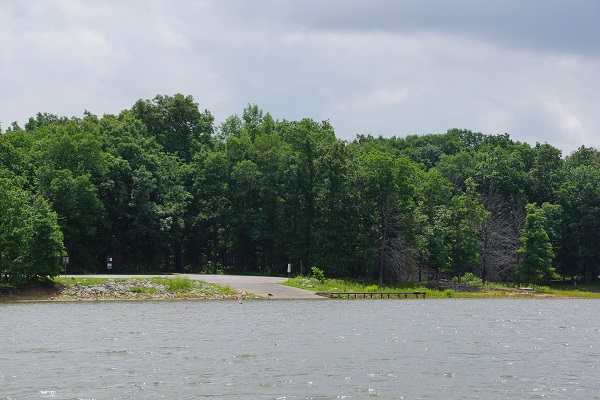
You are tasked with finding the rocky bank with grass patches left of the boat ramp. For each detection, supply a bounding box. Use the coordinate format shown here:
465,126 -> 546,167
0,279 -> 246,302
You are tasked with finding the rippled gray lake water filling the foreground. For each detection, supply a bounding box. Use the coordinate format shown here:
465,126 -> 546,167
0,299 -> 600,400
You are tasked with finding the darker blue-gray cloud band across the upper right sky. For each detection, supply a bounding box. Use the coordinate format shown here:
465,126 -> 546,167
228,0 -> 600,54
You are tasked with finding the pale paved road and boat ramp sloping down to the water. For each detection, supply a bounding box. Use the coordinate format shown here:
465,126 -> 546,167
68,274 -> 323,299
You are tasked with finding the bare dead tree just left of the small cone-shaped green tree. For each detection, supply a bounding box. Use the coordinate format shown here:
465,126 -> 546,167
475,192 -> 524,282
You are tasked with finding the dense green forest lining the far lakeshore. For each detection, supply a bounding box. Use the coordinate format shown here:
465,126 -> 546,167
0,94 -> 600,284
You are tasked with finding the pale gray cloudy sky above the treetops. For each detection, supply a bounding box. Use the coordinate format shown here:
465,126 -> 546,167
0,0 -> 600,155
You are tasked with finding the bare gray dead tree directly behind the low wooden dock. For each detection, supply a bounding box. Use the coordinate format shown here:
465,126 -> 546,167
375,198 -> 416,286
